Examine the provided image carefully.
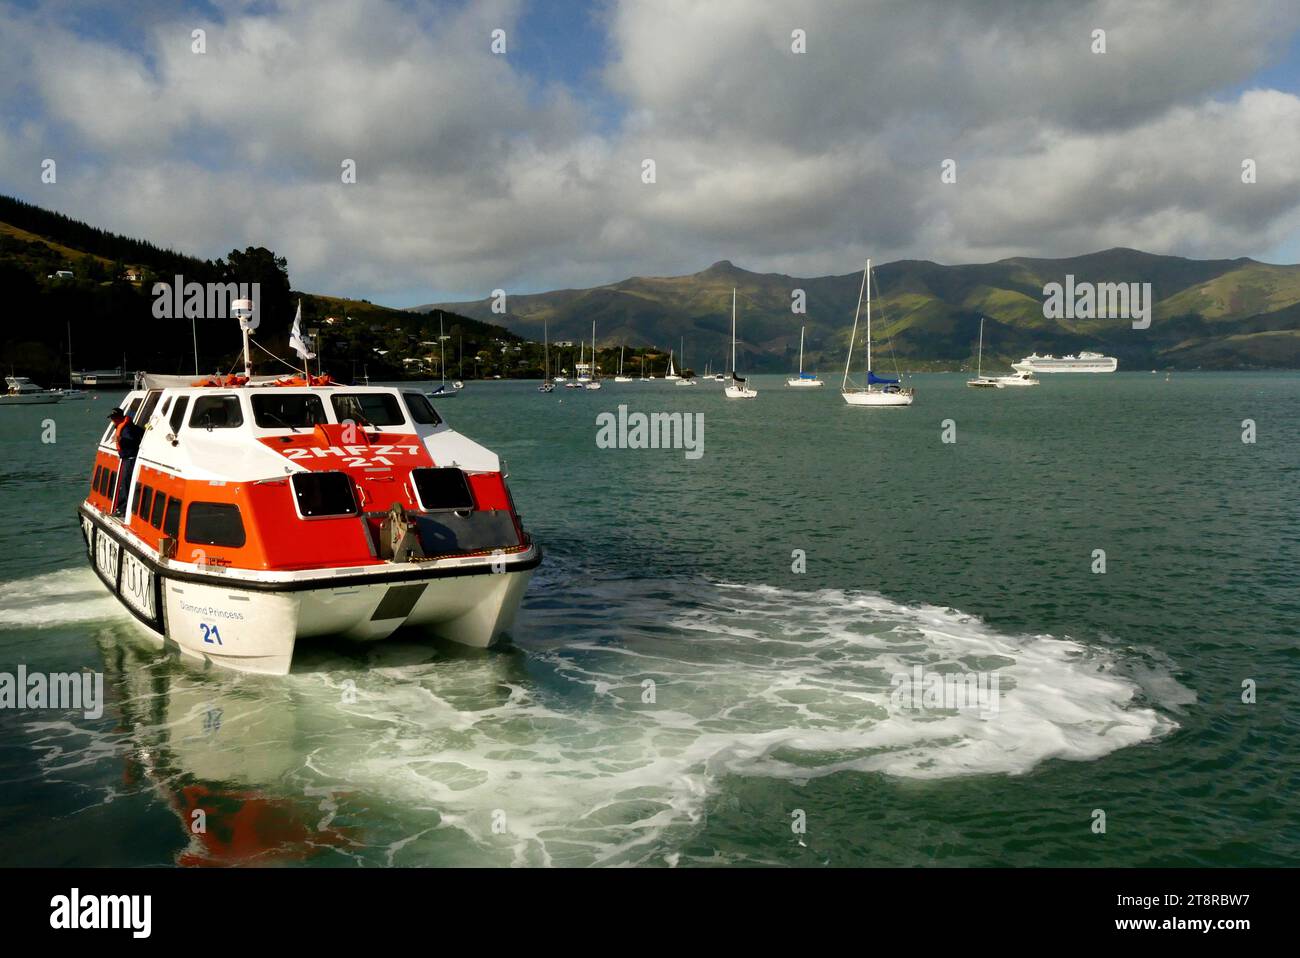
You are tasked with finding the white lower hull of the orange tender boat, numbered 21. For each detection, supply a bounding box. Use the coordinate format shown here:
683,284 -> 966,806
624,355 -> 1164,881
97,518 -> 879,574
79,506 -> 541,675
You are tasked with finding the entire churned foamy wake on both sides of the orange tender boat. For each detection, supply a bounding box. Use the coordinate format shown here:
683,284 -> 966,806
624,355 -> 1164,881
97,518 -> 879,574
0,571 -> 1177,864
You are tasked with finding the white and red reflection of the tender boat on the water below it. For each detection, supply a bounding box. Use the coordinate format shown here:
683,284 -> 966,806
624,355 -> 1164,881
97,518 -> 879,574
96,624 -> 520,866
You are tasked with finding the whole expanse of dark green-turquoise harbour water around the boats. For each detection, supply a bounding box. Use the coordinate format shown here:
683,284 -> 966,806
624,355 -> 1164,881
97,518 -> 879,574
0,373 -> 1300,866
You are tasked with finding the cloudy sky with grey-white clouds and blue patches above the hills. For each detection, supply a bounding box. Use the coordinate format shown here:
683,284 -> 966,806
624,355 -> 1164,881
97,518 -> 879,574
0,0 -> 1300,305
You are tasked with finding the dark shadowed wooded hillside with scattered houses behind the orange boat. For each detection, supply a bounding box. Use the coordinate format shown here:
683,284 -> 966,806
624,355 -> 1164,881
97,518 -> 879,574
0,196 -> 517,385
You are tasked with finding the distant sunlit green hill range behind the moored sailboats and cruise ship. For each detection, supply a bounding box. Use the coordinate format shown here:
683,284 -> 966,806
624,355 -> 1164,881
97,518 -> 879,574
419,248 -> 1300,370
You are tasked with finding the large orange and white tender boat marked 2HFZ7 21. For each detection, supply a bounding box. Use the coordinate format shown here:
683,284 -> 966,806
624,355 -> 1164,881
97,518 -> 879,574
78,356 -> 541,675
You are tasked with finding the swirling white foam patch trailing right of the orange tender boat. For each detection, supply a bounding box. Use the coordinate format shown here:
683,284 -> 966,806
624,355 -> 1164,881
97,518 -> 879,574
289,581 -> 1177,864
